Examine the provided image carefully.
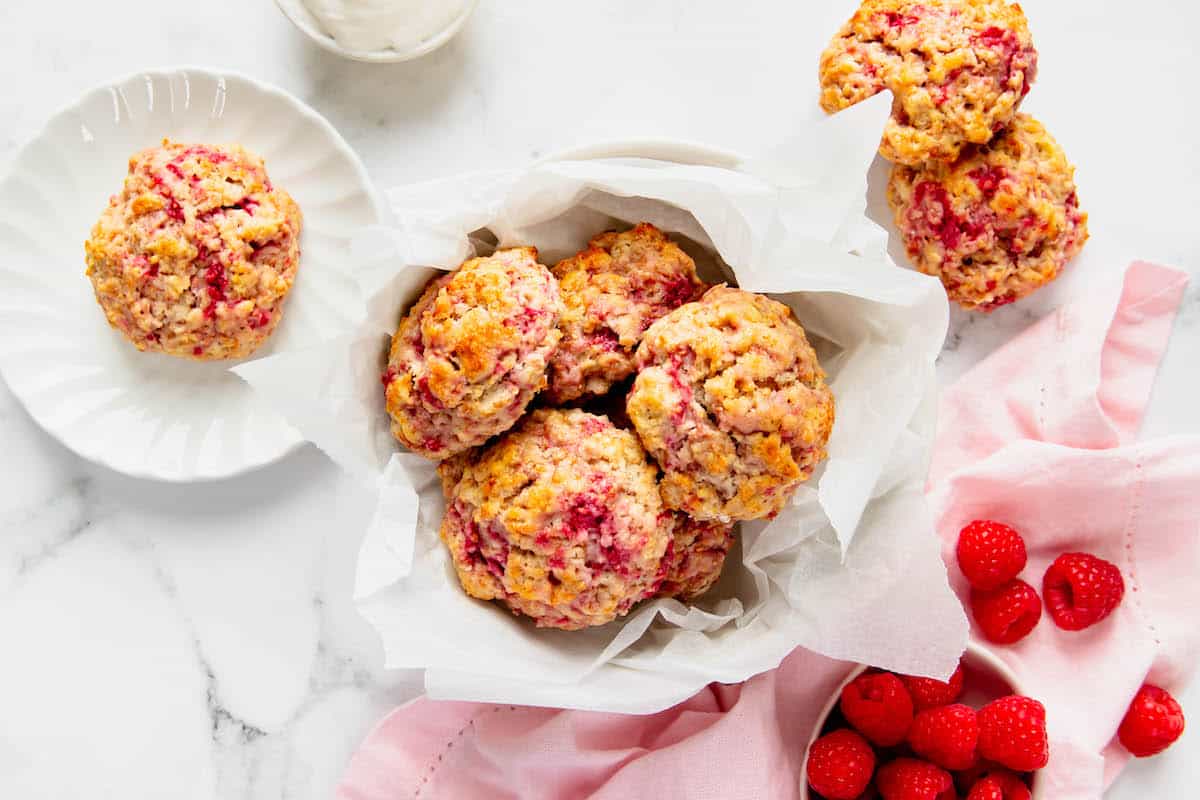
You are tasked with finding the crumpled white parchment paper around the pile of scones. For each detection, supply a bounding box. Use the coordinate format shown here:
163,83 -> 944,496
238,98 -> 967,712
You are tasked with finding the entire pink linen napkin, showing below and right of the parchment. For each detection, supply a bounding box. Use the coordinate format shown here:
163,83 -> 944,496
338,263 -> 1200,800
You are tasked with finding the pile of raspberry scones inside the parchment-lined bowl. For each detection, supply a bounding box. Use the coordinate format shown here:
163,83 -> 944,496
383,223 -> 834,630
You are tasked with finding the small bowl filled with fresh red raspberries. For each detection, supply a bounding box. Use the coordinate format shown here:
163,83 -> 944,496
800,643 -> 1049,800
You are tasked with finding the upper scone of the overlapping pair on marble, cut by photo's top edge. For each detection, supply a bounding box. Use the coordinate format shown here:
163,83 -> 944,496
821,0 -> 1038,166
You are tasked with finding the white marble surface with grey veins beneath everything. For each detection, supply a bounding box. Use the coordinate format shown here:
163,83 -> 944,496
0,0 -> 1200,800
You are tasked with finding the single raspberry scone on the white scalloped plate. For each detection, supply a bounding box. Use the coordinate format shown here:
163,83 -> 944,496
84,139 -> 301,360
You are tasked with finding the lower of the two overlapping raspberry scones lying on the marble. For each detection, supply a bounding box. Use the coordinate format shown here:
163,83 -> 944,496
888,114 -> 1087,311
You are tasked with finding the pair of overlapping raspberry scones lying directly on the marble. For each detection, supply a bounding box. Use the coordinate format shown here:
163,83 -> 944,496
821,0 -> 1087,312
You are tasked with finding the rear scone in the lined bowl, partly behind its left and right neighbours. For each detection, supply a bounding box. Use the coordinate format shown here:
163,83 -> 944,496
547,222 -> 706,403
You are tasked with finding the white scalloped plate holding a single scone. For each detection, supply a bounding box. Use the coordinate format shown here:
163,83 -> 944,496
0,68 -> 382,481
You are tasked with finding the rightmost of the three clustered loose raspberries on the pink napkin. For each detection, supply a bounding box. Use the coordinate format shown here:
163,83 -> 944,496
1042,553 -> 1124,631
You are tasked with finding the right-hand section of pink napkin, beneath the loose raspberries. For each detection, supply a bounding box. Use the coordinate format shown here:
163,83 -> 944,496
928,263 -> 1200,800
